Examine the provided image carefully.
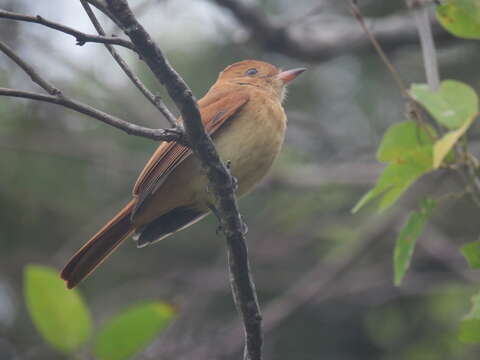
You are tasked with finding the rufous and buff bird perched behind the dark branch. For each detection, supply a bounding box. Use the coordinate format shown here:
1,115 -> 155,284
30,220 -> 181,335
61,60 -> 306,289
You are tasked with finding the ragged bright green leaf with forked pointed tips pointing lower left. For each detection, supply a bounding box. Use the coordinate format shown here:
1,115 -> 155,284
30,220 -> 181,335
352,145 -> 433,213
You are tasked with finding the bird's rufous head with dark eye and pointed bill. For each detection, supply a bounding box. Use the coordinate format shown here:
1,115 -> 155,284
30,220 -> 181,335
217,60 -> 306,101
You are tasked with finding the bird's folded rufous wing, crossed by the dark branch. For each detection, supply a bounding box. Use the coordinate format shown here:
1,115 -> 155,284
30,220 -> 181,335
132,90 -> 249,217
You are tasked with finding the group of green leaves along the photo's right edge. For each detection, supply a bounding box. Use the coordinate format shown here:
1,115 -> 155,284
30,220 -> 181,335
352,0 -> 480,343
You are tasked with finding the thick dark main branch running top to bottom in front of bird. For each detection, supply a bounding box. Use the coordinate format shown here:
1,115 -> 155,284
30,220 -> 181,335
107,0 -> 262,360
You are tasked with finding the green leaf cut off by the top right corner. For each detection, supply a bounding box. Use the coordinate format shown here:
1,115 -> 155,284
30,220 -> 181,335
436,0 -> 480,39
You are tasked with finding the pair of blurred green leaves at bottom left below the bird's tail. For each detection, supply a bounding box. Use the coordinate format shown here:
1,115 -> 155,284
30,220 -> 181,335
24,265 -> 175,360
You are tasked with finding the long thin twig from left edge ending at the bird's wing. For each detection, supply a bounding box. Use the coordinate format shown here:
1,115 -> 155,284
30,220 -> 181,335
0,88 -> 181,141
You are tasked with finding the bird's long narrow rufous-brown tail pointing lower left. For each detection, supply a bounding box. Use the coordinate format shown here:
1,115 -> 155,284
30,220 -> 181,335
61,200 -> 134,289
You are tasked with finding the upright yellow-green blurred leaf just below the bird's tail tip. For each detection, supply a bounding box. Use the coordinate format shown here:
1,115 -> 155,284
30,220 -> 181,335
23,265 -> 92,353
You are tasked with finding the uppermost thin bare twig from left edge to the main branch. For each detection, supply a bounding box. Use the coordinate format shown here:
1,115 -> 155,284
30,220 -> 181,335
0,10 -> 135,51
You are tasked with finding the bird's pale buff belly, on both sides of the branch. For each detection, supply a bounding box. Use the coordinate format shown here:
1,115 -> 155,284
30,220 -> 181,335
135,102 -> 286,226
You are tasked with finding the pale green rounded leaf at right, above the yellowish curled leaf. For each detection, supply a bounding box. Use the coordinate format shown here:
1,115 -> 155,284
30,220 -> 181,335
410,80 -> 478,130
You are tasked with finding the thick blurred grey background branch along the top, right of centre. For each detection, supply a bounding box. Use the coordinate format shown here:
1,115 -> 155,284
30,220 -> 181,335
213,0 -> 452,62
